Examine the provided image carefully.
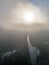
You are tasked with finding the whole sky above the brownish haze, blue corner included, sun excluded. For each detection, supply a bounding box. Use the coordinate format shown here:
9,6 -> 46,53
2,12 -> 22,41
0,0 -> 49,28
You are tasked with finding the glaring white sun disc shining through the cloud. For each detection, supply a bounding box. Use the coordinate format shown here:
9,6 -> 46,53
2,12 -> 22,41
23,11 -> 34,24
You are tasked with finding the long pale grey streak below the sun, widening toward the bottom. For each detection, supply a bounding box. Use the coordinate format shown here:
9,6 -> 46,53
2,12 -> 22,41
27,36 -> 40,65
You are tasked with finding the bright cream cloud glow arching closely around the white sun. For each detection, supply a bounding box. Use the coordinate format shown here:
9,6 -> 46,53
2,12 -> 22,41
10,2 -> 47,24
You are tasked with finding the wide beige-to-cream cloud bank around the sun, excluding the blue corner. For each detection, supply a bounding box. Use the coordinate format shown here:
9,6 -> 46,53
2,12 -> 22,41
0,0 -> 48,29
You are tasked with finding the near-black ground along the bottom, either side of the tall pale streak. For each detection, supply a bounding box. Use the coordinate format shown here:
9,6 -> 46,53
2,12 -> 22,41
0,47 -> 49,65
